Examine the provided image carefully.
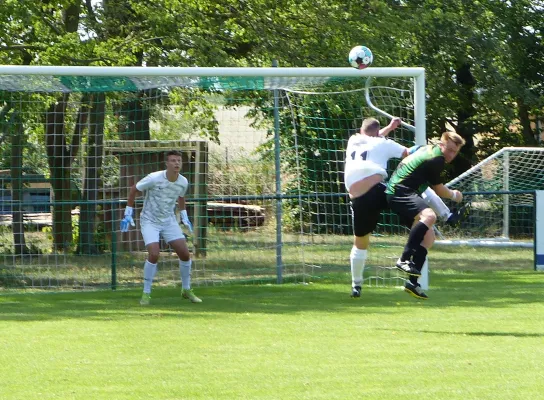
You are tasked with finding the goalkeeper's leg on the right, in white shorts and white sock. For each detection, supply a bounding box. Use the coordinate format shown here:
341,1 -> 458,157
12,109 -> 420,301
162,222 -> 202,303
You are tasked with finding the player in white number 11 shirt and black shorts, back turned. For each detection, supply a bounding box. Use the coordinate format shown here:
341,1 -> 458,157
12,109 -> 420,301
344,118 -> 408,297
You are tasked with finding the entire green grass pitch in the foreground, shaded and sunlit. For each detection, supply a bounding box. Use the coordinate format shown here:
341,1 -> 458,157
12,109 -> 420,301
0,266 -> 544,400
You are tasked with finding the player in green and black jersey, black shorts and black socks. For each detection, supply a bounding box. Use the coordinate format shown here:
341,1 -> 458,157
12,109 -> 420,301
385,132 -> 465,299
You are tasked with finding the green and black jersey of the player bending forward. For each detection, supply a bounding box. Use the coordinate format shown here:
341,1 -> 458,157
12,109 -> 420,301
385,145 -> 446,194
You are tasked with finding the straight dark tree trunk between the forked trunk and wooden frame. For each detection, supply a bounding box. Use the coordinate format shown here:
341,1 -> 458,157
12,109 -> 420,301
77,93 -> 106,254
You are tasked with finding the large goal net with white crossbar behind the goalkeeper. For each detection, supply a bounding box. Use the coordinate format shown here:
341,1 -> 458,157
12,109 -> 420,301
0,66 -> 425,288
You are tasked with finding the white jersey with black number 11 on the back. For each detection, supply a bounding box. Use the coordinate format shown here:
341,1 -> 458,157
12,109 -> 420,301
344,134 -> 405,191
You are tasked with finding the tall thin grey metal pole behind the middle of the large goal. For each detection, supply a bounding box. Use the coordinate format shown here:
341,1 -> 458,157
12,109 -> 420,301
272,60 -> 283,283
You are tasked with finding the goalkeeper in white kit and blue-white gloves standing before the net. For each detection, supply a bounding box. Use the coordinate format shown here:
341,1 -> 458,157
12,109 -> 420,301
121,150 -> 202,305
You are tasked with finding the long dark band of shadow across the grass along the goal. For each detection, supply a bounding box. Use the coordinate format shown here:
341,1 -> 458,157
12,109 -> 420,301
0,271 -> 544,322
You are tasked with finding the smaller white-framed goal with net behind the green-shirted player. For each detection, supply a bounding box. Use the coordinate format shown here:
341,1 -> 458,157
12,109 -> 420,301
437,147 -> 544,247
